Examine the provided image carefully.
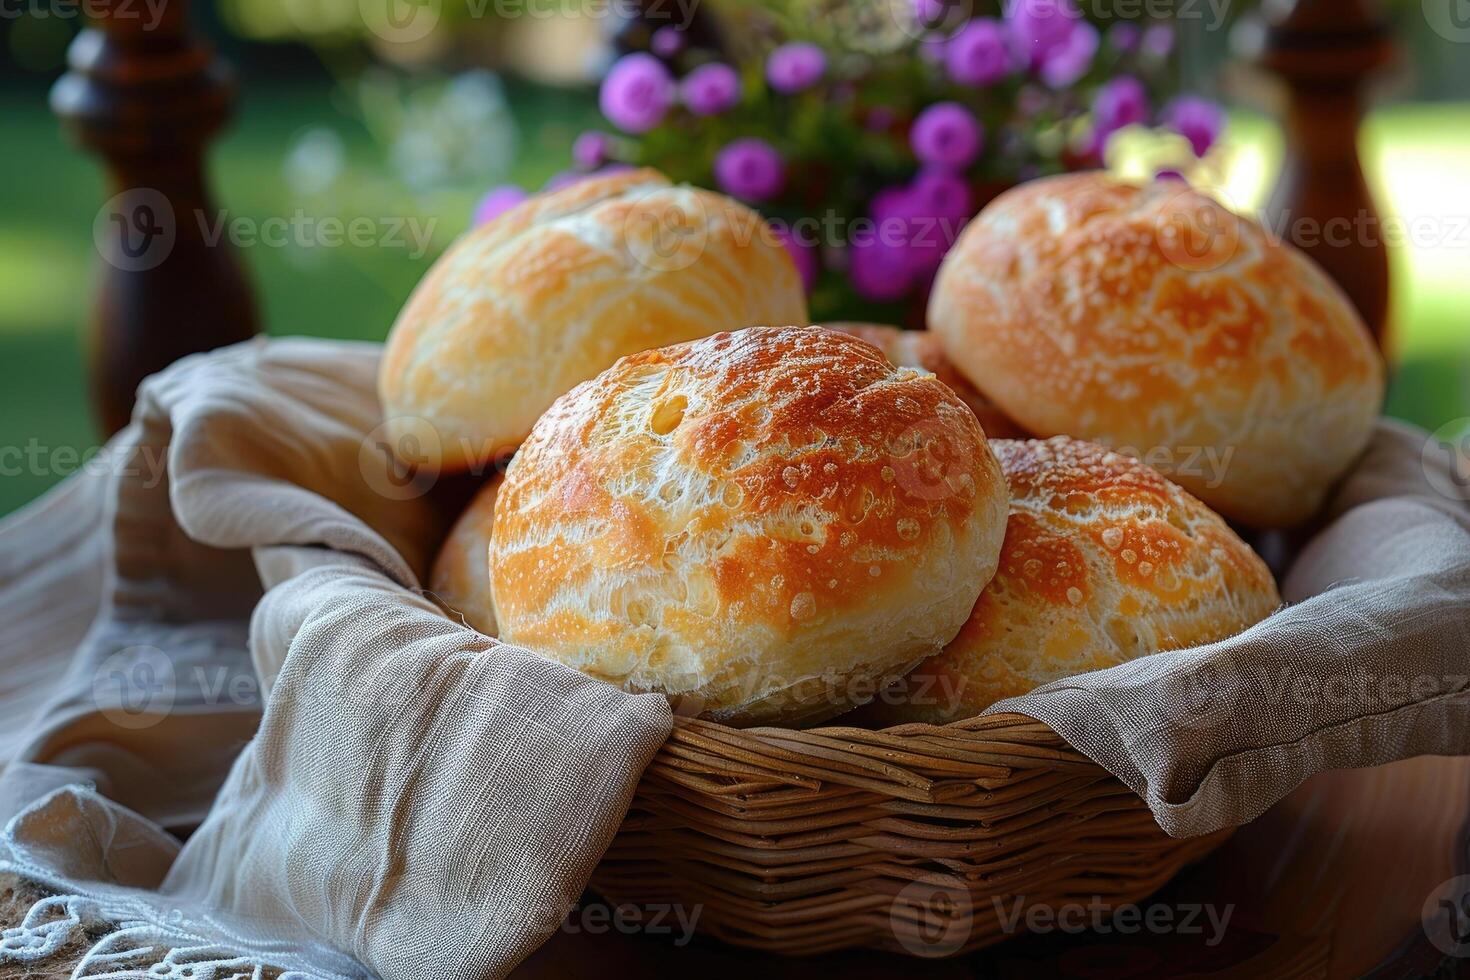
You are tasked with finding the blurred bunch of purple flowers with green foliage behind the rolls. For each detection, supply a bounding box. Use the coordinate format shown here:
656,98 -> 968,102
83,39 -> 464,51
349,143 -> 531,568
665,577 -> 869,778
478,0 -> 1225,323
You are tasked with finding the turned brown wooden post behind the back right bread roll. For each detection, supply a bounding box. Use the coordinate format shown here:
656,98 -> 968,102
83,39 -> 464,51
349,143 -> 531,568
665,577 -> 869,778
1245,0 -> 1395,345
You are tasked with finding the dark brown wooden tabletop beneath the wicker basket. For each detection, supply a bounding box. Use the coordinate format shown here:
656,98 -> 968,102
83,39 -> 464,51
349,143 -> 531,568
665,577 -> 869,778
513,757 -> 1470,980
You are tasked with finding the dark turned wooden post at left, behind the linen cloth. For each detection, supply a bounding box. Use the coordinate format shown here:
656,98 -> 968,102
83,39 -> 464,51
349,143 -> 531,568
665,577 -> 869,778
51,0 -> 257,435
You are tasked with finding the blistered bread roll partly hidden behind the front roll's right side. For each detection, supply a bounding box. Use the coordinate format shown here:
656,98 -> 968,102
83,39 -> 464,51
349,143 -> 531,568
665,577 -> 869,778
875,436 -> 1280,723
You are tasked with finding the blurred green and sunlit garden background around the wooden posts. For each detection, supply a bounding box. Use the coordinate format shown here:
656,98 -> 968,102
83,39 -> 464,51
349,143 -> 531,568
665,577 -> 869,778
0,0 -> 1470,514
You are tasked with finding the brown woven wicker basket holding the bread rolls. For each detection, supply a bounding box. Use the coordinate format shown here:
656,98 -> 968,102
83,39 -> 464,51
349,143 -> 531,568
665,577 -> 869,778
592,714 -> 1229,956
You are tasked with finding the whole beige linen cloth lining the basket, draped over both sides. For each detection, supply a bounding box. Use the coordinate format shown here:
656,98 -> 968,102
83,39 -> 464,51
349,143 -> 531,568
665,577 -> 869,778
0,341 -> 1470,979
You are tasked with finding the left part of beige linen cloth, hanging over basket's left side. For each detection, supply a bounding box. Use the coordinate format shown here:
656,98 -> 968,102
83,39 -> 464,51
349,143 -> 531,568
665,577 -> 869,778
0,341 -> 672,979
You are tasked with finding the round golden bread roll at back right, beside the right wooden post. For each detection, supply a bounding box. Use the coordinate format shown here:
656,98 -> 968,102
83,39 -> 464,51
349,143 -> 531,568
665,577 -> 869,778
929,173 -> 1383,526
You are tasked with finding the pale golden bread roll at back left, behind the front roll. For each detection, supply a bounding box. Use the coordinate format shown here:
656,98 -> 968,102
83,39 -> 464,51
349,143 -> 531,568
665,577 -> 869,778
378,170 -> 807,470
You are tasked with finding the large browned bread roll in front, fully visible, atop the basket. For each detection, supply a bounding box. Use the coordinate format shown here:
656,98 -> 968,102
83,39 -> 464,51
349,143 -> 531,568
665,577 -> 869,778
491,326 -> 1005,724
